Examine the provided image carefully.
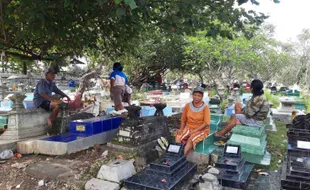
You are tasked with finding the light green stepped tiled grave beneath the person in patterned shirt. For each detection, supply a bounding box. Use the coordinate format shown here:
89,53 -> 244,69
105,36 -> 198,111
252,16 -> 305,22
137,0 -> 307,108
228,125 -> 270,165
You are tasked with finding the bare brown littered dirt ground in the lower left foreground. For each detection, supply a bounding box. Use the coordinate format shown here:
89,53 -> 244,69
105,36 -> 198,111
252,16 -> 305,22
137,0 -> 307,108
0,145 -> 133,190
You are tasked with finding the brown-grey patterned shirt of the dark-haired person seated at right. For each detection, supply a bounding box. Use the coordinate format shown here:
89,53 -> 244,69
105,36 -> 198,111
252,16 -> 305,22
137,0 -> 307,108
244,95 -> 270,121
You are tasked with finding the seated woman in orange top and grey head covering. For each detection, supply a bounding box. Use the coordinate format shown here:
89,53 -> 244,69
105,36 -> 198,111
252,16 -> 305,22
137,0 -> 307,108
175,86 -> 211,155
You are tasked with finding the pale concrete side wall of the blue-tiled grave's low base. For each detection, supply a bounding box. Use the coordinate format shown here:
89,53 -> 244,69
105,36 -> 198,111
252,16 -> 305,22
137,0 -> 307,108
35,129 -> 117,155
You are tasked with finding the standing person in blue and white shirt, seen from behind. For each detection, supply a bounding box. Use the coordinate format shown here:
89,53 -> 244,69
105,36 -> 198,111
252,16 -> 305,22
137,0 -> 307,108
109,62 -> 128,111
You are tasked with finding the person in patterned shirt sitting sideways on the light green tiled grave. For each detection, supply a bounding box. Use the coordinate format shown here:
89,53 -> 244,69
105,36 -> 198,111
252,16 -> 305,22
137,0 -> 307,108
214,79 -> 269,138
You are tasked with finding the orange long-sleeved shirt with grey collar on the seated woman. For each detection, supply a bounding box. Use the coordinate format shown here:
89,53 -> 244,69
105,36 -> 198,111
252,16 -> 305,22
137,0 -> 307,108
181,103 -> 211,129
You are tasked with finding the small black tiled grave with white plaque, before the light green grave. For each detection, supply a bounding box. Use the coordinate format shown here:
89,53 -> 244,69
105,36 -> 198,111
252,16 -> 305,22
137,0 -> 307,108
215,144 -> 254,189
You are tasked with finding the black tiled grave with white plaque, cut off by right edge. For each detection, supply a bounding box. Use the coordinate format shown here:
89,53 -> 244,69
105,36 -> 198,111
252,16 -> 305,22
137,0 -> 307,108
281,114 -> 310,190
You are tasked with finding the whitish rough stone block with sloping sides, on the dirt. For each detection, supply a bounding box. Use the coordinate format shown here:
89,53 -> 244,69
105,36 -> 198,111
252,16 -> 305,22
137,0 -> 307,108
97,160 -> 136,183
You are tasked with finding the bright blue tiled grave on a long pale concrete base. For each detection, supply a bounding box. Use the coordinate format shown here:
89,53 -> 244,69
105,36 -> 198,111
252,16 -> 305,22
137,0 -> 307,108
36,116 -> 123,155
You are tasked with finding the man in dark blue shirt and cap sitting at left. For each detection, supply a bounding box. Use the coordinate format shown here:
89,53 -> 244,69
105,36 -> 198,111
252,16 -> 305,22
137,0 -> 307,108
33,68 -> 70,127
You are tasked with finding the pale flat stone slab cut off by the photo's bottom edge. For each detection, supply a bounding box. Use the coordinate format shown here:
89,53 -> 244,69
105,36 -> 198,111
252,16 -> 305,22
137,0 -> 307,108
85,178 -> 119,190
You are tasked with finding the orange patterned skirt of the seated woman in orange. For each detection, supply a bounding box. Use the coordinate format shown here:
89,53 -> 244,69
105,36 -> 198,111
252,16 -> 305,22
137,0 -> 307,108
176,127 -> 210,150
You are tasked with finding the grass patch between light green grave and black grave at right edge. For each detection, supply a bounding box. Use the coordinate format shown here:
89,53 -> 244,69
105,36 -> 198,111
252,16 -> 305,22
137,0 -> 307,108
257,121 -> 287,171
